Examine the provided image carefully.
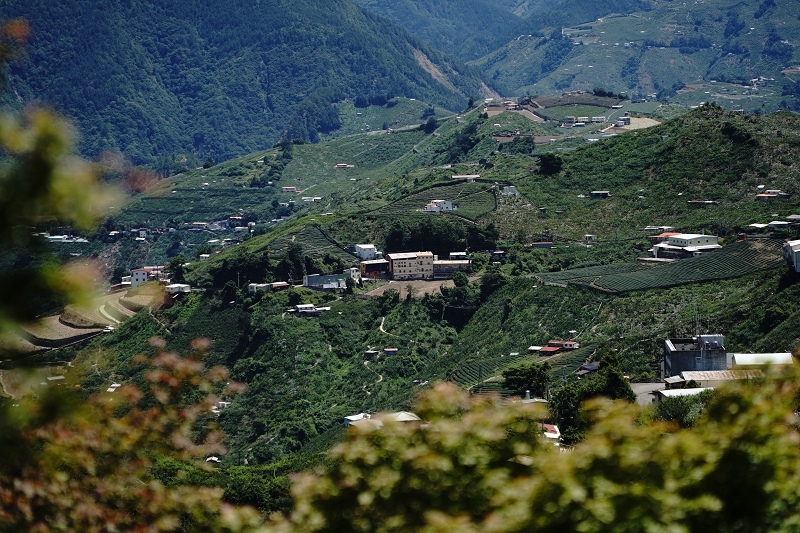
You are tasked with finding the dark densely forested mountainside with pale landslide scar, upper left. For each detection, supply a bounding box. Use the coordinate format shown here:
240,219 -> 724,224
0,0 -> 484,162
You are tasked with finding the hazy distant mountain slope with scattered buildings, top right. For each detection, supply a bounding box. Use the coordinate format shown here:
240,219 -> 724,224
475,0 -> 800,107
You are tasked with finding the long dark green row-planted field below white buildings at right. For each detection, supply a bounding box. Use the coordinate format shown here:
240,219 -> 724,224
539,240 -> 784,292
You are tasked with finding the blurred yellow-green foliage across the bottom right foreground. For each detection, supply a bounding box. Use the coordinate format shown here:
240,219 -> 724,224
287,377 -> 800,533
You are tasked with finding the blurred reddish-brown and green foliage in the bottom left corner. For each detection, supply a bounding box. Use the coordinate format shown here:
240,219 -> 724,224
0,340 -> 261,531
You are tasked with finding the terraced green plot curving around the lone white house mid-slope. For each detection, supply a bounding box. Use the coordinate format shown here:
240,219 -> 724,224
367,183 -> 497,220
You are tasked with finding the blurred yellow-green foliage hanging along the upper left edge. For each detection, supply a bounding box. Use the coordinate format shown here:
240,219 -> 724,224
0,20 -> 115,332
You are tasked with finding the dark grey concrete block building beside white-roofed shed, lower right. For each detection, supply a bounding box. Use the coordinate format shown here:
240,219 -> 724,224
662,334 -> 728,378
